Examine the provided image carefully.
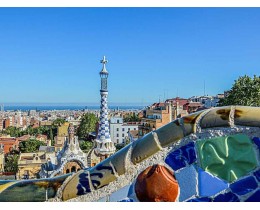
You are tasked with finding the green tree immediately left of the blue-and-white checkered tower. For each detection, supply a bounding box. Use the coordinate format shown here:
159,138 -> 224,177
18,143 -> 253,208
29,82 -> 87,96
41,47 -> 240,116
77,113 -> 98,139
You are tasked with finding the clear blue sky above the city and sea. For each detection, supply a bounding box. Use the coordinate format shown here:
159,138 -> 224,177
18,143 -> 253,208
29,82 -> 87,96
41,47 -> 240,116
0,8 -> 260,104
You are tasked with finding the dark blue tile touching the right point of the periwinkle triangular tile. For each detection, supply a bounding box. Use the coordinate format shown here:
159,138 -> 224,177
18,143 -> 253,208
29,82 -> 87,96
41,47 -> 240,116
230,176 -> 257,195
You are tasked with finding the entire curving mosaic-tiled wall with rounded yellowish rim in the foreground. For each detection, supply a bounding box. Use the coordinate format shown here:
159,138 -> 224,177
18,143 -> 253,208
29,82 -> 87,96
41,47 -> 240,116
0,106 -> 260,202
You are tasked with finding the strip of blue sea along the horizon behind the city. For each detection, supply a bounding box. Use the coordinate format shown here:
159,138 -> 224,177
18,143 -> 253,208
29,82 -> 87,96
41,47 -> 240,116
3,104 -> 145,111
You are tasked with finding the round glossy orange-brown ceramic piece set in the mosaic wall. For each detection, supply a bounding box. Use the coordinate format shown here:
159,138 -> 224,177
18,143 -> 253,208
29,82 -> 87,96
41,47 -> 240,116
135,165 -> 179,202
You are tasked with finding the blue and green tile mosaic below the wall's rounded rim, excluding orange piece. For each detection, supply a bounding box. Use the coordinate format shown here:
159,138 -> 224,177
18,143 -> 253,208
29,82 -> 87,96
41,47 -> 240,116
93,134 -> 260,202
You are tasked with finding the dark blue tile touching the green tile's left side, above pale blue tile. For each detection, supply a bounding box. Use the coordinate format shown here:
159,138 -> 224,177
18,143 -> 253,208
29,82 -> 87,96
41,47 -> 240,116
165,142 -> 196,171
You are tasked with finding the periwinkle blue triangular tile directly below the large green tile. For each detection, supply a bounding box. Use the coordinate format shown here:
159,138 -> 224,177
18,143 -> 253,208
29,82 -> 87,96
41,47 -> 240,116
198,168 -> 228,196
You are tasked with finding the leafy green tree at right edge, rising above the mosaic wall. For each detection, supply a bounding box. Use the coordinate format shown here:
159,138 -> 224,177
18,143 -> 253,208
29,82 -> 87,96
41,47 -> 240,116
219,75 -> 260,106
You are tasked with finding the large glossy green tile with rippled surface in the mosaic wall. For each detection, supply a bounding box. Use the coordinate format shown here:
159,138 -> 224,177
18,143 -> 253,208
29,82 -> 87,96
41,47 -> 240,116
196,134 -> 257,182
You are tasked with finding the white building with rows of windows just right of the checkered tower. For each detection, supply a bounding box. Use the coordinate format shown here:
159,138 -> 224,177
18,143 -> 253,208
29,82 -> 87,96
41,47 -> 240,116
110,117 -> 138,144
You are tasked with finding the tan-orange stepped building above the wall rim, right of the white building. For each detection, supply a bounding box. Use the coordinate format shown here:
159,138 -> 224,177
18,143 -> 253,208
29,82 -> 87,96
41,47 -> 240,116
138,103 -> 172,138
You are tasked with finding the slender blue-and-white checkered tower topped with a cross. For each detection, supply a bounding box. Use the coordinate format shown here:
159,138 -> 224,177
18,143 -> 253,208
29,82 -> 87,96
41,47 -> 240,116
95,56 -> 116,158
